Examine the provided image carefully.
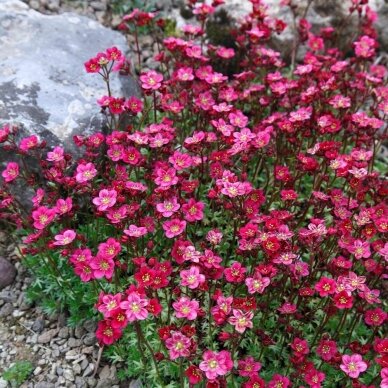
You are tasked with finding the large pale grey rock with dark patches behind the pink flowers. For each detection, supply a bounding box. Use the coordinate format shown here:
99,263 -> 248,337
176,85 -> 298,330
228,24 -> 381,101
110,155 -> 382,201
0,0 -> 137,155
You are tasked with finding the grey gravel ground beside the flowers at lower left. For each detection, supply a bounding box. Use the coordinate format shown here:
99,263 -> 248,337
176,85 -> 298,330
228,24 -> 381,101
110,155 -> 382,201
0,231 -> 140,388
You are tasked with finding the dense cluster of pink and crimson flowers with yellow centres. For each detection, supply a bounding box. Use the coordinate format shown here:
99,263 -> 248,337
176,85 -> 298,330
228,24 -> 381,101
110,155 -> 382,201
0,0 -> 388,388
